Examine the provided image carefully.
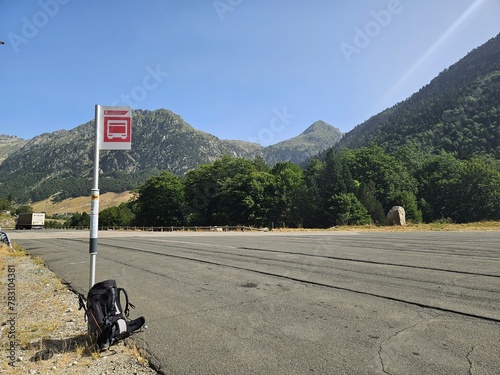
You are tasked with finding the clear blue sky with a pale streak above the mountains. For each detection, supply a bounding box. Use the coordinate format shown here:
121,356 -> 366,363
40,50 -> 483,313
0,0 -> 500,147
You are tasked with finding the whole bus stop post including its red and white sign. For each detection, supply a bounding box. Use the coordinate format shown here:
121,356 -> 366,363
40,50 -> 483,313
89,104 -> 132,289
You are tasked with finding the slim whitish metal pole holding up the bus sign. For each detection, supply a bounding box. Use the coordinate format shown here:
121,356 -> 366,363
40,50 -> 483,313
89,104 -> 102,289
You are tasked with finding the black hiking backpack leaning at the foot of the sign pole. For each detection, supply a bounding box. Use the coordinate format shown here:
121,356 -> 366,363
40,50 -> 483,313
79,280 -> 146,350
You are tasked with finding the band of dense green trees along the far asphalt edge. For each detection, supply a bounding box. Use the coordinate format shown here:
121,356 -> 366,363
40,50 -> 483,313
88,145 -> 500,228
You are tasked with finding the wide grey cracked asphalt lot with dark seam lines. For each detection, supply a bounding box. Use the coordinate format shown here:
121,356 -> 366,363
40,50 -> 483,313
9,231 -> 500,375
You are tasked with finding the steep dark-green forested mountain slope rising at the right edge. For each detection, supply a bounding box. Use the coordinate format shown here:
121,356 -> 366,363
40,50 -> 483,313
339,34 -> 500,159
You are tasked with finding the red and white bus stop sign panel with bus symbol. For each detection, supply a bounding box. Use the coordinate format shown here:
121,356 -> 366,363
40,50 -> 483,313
97,106 -> 132,150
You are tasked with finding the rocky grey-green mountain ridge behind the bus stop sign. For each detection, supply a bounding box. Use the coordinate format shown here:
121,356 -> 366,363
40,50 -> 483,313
0,109 -> 341,201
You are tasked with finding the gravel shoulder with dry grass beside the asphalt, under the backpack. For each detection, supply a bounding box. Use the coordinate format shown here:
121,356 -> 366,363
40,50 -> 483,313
0,245 -> 157,375
